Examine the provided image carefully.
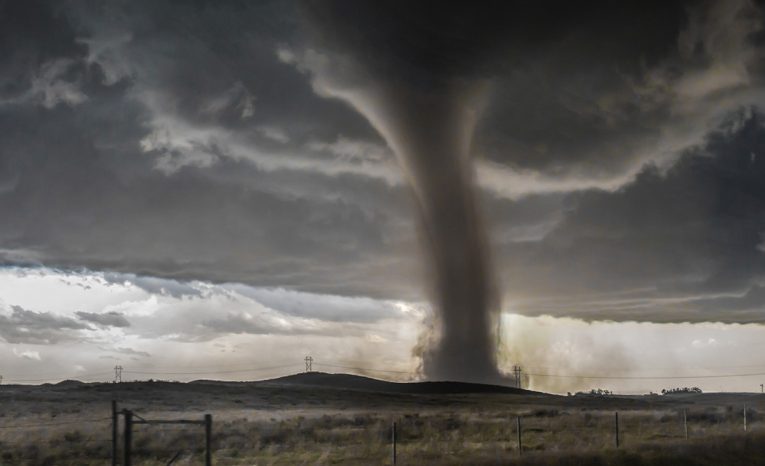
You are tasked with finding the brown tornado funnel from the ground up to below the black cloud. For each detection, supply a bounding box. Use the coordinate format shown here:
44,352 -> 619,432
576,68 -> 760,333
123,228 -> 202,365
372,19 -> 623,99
351,82 -> 499,382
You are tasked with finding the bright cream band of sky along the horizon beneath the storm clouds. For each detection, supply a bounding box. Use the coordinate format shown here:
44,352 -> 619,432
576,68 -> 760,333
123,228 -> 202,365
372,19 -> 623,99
0,268 -> 765,393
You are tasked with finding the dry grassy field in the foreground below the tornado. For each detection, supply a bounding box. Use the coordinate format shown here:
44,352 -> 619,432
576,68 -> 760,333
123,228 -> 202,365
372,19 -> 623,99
0,376 -> 765,465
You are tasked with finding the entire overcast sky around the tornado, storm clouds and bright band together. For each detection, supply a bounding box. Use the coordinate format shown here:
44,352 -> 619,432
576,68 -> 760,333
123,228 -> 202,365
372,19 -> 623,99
0,0 -> 765,392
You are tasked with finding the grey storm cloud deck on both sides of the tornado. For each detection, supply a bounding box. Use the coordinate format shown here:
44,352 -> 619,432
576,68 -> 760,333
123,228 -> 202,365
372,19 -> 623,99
0,1 -> 765,328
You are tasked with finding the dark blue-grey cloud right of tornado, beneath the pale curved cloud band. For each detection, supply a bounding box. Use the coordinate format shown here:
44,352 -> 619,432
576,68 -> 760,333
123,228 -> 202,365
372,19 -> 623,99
506,110 -> 765,321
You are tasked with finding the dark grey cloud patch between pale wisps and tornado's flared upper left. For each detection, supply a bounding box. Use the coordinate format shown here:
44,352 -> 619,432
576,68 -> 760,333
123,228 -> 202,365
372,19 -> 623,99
70,1 -> 374,147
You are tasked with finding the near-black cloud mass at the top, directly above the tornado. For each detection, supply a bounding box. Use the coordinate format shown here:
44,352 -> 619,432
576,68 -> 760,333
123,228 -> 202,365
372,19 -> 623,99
303,0 -> 687,82
